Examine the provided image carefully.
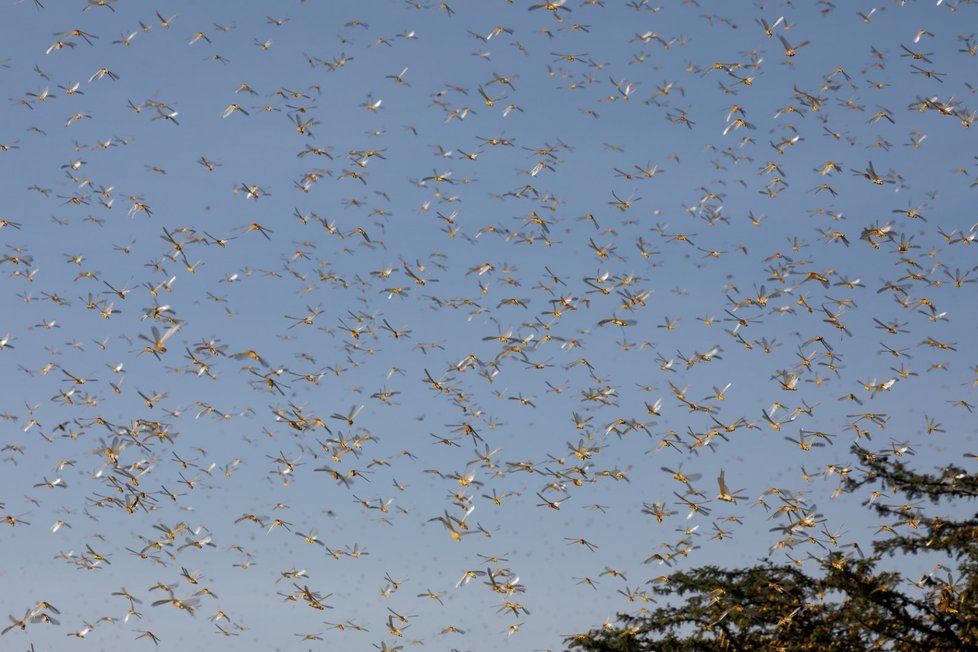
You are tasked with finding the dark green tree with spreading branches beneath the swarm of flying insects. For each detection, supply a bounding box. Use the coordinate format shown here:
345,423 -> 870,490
565,446 -> 978,652
